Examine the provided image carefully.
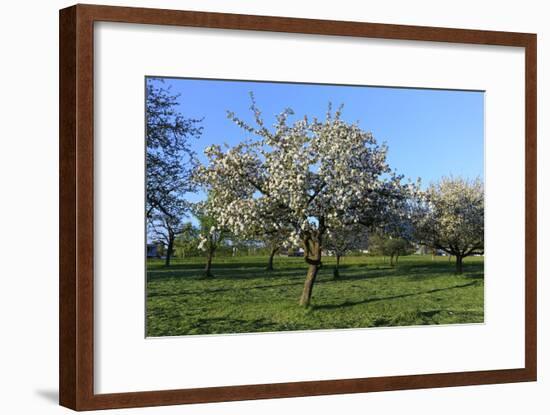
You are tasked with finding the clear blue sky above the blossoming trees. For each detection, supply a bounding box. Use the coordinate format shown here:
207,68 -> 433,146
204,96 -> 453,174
149,78 -> 484,205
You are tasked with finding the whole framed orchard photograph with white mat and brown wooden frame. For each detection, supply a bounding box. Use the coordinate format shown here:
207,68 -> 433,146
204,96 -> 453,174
59,5 -> 537,410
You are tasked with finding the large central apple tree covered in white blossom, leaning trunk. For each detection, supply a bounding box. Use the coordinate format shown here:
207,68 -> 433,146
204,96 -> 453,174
197,94 -> 407,306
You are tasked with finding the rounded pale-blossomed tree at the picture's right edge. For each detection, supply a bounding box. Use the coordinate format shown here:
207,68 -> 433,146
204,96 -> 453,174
416,177 -> 485,274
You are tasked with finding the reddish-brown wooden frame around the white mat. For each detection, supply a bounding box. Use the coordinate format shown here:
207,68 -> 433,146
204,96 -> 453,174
59,5 -> 537,410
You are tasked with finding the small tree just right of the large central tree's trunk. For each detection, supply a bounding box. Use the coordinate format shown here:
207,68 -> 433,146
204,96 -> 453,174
325,225 -> 368,279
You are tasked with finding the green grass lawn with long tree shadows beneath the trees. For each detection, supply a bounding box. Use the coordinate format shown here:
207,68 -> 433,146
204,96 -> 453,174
147,255 -> 483,336
